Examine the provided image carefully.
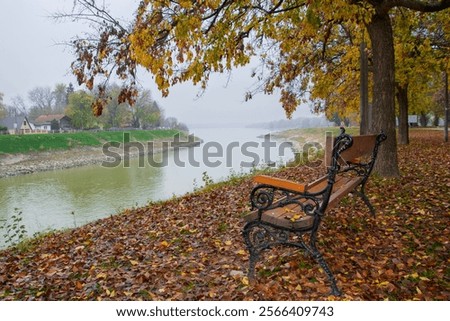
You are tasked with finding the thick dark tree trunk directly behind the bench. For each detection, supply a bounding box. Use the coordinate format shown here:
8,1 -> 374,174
367,12 -> 400,177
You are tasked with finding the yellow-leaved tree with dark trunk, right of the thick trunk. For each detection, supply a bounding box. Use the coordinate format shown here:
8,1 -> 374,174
394,10 -> 450,144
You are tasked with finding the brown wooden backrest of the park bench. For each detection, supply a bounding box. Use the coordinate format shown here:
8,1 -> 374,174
325,135 -> 378,167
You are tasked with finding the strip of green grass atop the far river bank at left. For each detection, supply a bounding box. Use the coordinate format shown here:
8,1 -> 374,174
0,129 -> 185,154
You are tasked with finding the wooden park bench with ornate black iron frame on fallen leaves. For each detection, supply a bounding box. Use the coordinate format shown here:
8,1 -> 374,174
243,128 -> 386,295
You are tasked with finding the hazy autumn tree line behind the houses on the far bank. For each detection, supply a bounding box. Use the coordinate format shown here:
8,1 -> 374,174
0,83 -> 188,131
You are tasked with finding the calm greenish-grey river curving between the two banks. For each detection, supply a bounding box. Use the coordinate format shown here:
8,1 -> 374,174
0,128 -> 293,247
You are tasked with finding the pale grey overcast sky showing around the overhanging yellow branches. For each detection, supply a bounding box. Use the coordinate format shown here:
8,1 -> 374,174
0,0 -> 311,125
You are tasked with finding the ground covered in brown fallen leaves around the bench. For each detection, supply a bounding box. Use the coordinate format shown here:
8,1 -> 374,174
0,131 -> 450,300
